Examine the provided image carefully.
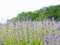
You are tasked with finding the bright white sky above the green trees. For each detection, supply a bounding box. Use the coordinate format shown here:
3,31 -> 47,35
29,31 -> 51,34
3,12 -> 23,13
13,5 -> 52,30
0,0 -> 60,23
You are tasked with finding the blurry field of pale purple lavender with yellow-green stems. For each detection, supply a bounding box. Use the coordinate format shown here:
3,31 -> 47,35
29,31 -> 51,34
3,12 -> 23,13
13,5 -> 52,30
0,20 -> 60,45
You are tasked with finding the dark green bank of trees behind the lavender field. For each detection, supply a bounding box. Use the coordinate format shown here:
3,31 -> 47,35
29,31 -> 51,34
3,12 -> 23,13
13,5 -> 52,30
11,5 -> 60,22
